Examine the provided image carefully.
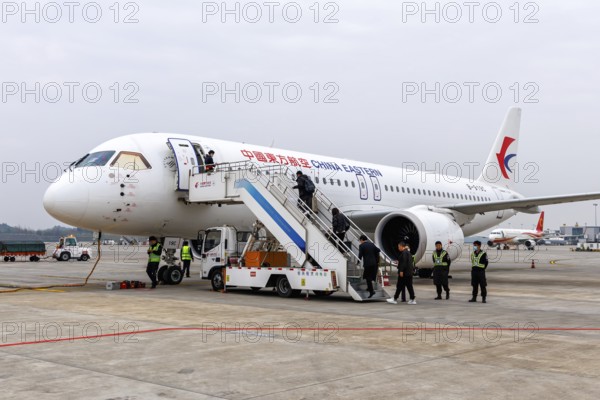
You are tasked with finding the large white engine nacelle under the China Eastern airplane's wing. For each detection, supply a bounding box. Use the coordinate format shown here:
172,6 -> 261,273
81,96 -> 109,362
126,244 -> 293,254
375,206 -> 465,267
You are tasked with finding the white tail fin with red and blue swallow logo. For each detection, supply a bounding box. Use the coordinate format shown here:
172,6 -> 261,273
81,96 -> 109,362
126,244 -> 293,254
478,107 -> 521,188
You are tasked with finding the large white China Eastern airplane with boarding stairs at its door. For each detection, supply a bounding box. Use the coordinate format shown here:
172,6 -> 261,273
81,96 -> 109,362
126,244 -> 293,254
43,108 -> 600,266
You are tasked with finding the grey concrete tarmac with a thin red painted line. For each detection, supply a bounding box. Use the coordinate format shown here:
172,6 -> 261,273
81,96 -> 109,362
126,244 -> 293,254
0,246 -> 600,400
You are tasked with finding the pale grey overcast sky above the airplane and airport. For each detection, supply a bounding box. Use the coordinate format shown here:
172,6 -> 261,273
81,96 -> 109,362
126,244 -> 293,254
0,0 -> 600,228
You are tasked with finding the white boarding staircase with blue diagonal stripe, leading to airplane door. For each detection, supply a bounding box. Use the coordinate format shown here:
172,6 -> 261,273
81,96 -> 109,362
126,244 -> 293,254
187,161 -> 391,301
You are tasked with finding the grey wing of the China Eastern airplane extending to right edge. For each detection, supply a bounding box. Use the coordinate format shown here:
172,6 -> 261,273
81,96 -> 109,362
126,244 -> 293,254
437,192 -> 600,214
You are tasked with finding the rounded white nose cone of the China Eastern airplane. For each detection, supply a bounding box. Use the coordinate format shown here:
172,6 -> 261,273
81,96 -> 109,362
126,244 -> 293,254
43,180 -> 89,226
